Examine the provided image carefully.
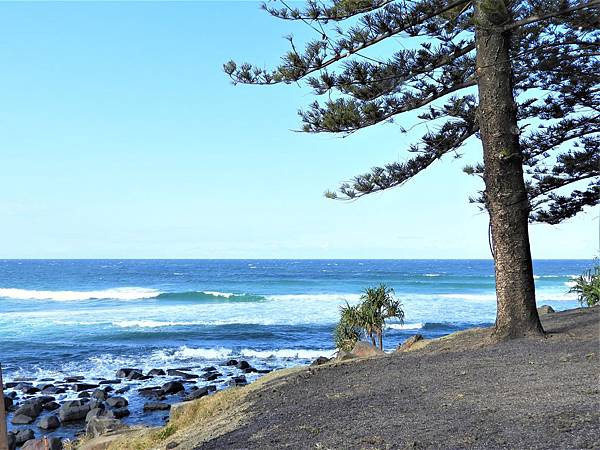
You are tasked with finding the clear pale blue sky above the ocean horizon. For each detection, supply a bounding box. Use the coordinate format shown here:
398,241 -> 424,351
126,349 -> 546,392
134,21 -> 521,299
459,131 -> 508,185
0,1 -> 599,258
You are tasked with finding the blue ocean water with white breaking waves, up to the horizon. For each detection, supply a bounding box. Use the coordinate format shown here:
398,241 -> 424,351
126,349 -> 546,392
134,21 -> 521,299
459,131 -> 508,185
0,260 -> 591,379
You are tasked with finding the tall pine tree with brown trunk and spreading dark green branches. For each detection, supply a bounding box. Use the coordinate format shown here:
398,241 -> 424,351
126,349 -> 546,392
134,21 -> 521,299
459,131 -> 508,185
224,0 -> 600,339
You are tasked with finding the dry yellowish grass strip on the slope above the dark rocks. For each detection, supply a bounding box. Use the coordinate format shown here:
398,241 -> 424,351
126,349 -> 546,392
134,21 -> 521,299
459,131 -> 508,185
91,368 -> 302,450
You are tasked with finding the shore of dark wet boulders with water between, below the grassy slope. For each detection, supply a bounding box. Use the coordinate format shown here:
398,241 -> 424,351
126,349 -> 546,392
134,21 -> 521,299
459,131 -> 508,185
4,359 -> 271,450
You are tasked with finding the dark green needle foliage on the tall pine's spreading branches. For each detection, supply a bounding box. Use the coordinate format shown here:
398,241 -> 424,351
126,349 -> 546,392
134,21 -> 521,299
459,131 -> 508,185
224,0 -> 600,224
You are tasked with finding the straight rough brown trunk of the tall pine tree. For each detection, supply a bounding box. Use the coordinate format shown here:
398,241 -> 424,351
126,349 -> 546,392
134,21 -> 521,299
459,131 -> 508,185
475,0 -> 544,339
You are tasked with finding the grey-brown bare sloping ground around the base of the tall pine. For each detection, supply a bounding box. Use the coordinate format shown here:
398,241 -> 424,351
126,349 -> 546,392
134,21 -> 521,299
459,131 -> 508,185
195,307 -> 600,450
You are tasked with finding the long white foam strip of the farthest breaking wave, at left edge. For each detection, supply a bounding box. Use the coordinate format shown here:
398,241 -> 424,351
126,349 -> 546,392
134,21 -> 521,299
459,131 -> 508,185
0,287 -> 161,301
